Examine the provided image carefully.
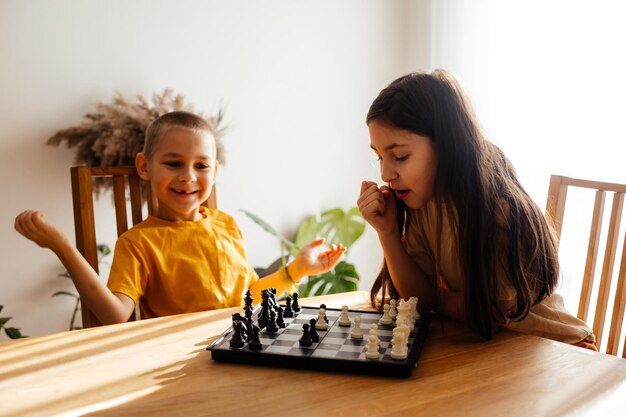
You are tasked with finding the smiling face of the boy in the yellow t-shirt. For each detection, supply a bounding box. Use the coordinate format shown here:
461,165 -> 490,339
135,127 -> 217,221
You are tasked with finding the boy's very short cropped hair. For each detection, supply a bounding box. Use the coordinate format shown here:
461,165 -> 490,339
142,111 -> 223,163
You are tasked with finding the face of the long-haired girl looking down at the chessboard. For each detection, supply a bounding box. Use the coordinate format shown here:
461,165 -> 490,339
368,119 -> 437,209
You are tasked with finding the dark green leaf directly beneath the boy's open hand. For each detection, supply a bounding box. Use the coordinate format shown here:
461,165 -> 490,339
298,261 -> 359,297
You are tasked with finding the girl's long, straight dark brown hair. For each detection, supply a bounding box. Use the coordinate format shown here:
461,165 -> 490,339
367,70 -> 559,338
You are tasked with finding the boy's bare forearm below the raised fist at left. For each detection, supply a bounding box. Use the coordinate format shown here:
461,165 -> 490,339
54,244 -> 132,324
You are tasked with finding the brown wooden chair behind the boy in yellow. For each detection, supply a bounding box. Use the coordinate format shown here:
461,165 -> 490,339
71,166 -> 217,327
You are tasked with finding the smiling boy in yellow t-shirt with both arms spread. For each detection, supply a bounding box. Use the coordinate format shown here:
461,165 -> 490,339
15,111 -> 346,324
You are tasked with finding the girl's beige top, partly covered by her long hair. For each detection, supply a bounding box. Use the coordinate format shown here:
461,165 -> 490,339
405,202 -> 595,343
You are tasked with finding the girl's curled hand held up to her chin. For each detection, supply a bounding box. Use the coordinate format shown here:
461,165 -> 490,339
357,181 -> 398,236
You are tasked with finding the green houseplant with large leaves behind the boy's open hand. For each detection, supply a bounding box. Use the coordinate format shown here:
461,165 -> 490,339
242,207 -> 365,297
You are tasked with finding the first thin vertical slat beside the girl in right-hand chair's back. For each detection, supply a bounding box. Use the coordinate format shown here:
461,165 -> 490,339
578,190 -> 606,321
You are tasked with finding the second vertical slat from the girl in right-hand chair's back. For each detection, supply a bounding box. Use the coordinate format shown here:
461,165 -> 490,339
593,193 -> 624,345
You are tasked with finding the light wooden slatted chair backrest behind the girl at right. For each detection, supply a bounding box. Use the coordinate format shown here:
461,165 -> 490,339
546,175 -> 626,357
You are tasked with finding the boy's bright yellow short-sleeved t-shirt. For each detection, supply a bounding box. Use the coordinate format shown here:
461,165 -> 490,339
107,207 -> 259,318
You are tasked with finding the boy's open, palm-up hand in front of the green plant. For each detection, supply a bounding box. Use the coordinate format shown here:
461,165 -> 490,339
289,238 -> 346,283
